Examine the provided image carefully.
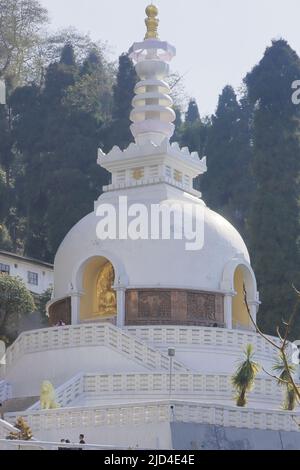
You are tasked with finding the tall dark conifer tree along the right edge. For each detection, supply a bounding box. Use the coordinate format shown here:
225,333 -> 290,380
246,40 -> 300,338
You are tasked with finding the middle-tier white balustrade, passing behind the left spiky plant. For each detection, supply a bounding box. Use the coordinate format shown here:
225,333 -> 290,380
28,373 -> 282,411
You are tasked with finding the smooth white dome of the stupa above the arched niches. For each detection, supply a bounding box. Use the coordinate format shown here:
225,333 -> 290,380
55,188 -> 250,298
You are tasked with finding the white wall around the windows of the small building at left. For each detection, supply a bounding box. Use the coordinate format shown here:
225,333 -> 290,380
0,252 -> 53,294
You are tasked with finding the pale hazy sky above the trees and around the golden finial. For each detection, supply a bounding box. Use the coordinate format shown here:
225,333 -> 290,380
40,0 -> 300,115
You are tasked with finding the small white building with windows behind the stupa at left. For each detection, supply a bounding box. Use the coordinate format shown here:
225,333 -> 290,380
0,250 -> 54,295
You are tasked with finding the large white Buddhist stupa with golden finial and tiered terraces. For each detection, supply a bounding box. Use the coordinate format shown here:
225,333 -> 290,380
0,5 -> 300,450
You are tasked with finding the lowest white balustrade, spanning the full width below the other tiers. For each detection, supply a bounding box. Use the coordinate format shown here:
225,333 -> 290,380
5,400 -> 300,434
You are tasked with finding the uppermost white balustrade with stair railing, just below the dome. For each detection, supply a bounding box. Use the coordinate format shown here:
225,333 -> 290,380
6,324 -> 284,372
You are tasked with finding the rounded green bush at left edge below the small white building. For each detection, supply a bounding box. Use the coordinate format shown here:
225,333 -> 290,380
0,274 -> 35,341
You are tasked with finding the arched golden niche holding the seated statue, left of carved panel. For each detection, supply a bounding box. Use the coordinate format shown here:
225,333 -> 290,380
80,256 -> 117,322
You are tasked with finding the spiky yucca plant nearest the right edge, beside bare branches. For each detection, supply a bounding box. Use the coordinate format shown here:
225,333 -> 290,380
273,353 -> 298,411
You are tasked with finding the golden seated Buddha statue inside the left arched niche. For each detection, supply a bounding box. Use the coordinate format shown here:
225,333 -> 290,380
97,262 -> 117,316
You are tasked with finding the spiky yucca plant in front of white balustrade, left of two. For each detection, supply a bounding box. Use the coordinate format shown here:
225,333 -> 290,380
232,344 -> 260,407
